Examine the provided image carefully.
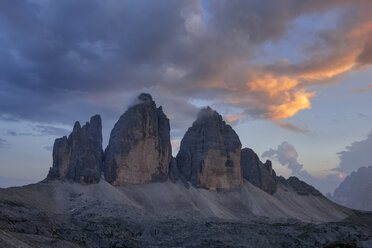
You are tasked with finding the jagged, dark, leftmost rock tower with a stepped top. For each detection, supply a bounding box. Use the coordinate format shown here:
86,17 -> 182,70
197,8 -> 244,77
47,115 -> 103,183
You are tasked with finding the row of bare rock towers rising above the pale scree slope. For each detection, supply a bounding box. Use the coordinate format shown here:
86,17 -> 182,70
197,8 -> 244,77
47,93 -> 319,194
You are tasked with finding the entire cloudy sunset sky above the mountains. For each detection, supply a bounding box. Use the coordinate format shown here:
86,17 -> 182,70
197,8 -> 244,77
0,0 -> 372,193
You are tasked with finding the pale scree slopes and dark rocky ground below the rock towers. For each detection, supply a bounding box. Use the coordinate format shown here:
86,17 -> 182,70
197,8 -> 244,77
0,181 -> 372,247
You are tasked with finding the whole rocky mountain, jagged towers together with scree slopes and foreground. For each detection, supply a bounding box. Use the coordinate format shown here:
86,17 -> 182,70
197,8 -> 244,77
0,94 -> 372,247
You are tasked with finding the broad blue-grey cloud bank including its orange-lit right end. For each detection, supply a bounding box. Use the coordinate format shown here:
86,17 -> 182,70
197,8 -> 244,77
0,0 -> 371,136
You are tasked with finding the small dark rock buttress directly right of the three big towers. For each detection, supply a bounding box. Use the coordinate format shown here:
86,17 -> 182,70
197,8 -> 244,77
240,148 -> 278,194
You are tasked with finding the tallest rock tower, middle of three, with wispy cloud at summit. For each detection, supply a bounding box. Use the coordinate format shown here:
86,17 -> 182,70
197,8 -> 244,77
104,93 -> 172,186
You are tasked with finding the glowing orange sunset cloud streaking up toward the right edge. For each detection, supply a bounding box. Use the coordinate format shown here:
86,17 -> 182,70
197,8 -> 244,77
198,17 -> 372,133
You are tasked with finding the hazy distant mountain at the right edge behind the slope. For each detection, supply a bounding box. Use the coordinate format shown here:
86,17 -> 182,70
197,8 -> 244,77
331,165 -> 372,211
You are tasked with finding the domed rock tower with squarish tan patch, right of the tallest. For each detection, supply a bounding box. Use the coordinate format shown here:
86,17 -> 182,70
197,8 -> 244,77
176,107 -> 243,190
